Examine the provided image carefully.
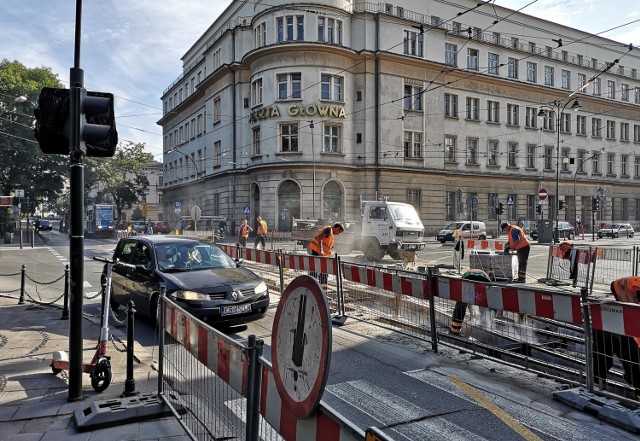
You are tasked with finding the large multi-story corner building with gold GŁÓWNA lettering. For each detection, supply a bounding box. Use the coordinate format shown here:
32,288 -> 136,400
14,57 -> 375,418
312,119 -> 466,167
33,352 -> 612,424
158,0 -> 640,231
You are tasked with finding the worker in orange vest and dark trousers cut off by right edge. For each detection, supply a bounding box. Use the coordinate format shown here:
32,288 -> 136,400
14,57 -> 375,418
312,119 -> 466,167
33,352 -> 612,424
592,276 -> 640,401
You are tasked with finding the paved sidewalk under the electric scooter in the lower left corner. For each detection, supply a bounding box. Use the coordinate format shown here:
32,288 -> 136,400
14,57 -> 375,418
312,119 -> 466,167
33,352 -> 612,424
0,292 -> 190,441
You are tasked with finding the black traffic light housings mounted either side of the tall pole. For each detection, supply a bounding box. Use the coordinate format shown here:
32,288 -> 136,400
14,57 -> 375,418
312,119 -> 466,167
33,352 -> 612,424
34,87 -> 118,157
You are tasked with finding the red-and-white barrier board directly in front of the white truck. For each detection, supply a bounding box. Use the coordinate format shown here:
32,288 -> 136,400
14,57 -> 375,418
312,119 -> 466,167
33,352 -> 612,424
342,263 -> 431,300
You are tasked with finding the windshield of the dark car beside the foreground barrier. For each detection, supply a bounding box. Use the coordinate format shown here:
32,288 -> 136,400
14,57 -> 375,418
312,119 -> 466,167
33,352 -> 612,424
155,242 -> 237,272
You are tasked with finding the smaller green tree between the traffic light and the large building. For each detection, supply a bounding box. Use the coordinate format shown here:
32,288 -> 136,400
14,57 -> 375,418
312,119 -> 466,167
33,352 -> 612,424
85,144 -> 153,219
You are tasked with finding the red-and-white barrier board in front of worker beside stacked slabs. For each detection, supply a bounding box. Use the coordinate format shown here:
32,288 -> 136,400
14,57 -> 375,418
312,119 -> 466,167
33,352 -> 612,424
436,276 -> 582,325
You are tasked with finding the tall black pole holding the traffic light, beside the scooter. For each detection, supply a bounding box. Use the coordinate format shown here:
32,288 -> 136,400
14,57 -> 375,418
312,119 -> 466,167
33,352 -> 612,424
67,0 -> 84,401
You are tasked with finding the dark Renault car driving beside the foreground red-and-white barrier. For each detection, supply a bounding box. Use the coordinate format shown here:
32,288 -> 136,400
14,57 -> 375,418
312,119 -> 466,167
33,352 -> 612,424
102,235 -> 269,325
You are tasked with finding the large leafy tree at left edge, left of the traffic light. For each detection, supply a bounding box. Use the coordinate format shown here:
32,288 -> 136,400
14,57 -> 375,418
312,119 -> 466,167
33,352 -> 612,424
0,59 -> 69,235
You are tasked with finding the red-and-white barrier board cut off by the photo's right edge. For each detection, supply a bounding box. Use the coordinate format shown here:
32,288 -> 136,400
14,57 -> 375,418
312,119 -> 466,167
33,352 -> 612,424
590,302 -> 640,338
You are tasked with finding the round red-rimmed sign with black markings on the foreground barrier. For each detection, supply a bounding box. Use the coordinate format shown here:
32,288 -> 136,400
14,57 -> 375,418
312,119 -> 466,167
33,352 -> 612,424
271,276 -> 331,418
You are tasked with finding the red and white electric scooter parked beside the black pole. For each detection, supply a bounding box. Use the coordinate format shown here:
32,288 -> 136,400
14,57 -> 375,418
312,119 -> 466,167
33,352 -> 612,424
51,256 -> 114,392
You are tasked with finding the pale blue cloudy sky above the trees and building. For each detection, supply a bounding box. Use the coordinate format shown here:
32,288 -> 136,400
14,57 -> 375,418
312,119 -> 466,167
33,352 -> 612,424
0,0 -> 640,161
